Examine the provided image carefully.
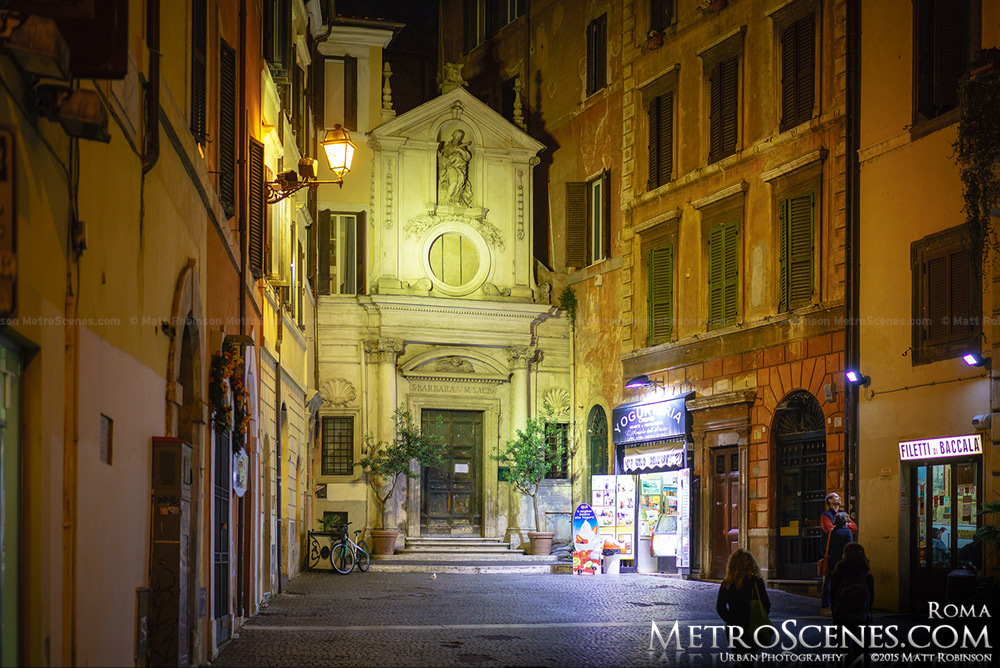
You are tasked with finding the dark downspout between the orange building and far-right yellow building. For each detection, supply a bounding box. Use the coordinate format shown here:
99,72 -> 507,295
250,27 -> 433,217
844,0 -> 861,519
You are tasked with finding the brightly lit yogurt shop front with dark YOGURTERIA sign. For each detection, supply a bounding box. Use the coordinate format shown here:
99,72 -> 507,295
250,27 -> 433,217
592,397 -> 692,574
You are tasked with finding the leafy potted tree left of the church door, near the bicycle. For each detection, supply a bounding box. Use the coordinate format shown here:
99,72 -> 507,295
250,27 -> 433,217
358,405 -> 444,555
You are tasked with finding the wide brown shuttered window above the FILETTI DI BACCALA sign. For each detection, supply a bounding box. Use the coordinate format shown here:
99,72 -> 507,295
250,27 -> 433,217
910,225 -> 982,365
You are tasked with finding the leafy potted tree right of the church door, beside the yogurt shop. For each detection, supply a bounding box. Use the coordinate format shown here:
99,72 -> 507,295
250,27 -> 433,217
493,418 -> 566,555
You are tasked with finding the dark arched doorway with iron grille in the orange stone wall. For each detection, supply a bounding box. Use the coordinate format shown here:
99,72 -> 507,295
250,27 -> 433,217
772,390 -> 826,580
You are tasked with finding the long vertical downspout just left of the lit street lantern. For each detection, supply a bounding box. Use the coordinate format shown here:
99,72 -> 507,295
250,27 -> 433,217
236,0 -> 248,617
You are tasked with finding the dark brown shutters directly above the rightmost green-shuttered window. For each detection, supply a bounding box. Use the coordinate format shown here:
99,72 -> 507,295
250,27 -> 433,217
781,14 -> 816,131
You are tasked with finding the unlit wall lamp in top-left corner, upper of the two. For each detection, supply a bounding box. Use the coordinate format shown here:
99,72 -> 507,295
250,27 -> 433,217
0,12 -> 70,81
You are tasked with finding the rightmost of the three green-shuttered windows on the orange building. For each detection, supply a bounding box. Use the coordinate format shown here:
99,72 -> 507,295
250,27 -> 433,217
778,192 -> 816,311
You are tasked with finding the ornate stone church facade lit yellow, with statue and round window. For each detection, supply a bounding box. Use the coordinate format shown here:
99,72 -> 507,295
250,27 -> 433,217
314,84 -> 577,545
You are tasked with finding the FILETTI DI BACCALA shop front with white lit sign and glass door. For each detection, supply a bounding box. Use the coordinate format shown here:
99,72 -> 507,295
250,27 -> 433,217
899,434 -> 983,610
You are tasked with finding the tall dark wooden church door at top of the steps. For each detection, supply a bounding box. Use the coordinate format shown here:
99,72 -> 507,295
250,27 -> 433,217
420,409 -> 483,536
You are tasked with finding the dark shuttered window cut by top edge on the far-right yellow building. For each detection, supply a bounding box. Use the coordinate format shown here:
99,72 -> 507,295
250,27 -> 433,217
914,0 -> 973,120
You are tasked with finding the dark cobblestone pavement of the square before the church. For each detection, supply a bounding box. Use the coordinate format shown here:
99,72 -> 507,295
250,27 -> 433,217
212,567 -> 992,667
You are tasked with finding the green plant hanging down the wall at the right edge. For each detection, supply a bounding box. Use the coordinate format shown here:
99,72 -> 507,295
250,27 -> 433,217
954,48 -> 1000,273
